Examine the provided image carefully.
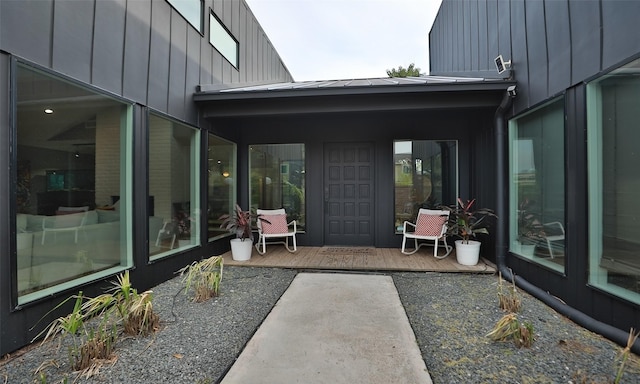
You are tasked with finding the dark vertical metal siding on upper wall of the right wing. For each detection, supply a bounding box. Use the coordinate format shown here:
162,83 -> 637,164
429,0 -> 640,108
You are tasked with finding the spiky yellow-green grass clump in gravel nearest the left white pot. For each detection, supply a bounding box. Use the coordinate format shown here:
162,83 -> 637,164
178,256 -> 223,302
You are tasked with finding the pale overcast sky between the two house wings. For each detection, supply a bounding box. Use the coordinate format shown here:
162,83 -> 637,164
246,0 -> 441,81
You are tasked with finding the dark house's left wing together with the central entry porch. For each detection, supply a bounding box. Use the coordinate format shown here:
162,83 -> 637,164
0,0 -> 513,354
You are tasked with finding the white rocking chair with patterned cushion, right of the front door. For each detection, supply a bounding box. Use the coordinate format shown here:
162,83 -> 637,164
402,208 -> 453,259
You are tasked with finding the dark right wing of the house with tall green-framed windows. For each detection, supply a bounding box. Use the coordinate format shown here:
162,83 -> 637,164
429,0 -> 640,348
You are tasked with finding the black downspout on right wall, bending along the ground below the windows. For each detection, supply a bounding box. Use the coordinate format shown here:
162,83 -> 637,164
495,85 -> 640,354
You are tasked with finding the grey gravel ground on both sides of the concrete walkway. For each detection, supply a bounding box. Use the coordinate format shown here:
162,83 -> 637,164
0,267 -> 640,384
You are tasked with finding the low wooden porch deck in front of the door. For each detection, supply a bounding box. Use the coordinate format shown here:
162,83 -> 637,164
223,245 -> 496,274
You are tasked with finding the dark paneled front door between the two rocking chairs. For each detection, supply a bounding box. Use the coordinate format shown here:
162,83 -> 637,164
324,143 -> 375,246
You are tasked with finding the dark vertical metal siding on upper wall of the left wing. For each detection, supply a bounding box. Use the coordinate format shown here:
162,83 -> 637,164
0,0 -> 292,124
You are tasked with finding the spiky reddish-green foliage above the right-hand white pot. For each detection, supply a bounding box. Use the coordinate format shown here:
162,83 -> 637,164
443,198 -> 497,244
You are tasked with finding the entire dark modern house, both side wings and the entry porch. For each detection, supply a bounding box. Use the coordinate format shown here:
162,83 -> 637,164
6,0 -> 640,354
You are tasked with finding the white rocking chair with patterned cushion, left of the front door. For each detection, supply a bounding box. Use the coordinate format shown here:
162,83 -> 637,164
256,208 -> 298,255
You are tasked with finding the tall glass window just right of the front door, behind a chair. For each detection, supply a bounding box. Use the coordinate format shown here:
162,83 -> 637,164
393,140 -> 458,232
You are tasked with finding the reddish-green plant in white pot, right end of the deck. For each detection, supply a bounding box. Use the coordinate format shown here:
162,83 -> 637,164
444,198 -> 497,265
